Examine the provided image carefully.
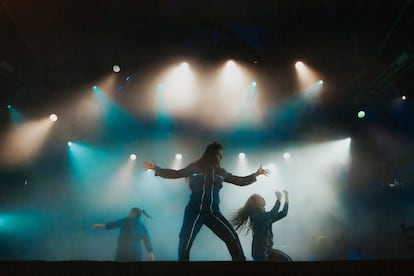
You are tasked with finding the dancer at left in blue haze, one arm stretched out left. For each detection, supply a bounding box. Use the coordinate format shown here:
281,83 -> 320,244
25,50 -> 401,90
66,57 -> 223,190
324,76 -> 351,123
92,208 -> 154,262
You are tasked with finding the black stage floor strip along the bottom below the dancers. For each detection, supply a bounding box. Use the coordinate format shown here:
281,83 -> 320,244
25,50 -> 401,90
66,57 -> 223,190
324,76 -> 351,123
0,260 -> 414,276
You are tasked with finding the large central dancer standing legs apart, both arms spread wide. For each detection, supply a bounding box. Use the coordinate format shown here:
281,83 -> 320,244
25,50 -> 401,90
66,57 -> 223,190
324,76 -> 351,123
144,142 -> 270,261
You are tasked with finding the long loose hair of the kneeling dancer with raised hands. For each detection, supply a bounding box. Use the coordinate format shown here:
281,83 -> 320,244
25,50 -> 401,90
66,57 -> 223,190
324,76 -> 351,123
230,194 -> 263,234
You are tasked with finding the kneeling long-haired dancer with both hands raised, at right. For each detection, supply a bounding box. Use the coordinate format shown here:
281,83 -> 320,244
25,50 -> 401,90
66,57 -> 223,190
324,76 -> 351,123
230,191 -> 291,261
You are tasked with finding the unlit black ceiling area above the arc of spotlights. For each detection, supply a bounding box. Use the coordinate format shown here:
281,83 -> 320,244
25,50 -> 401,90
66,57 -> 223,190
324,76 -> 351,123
0,0 -> 414,138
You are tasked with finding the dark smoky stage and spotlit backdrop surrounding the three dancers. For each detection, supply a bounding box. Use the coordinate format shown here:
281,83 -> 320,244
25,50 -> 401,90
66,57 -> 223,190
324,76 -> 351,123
0,0 -> 414,275
